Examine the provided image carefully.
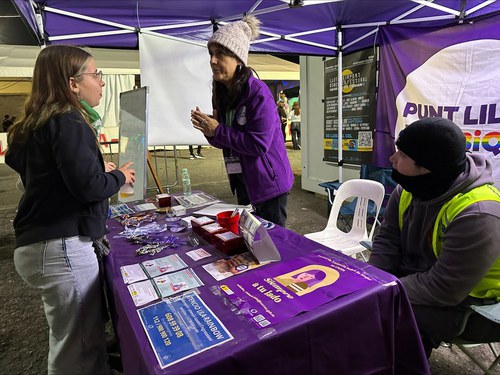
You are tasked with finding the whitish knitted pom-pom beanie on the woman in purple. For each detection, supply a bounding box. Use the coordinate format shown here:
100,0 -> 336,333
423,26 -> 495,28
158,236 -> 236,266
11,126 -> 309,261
208,16 -> 260,66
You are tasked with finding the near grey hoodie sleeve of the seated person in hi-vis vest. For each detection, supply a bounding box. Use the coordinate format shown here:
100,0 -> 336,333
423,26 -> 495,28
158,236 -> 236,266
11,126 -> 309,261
401,201 -> 500,306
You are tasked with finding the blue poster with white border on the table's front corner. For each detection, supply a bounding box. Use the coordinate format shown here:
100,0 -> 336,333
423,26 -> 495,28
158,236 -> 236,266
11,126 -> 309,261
137,291 -> 233,369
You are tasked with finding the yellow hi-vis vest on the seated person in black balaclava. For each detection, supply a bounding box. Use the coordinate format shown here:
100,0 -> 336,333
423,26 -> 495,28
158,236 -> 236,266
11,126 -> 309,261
399,185 -> 500,301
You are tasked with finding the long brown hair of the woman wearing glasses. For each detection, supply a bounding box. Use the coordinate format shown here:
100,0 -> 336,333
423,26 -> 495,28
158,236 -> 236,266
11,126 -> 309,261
8,45 -> 92,150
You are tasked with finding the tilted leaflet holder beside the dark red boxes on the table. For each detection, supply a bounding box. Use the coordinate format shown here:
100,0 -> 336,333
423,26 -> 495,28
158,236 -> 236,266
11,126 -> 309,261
238,210 -> 281,263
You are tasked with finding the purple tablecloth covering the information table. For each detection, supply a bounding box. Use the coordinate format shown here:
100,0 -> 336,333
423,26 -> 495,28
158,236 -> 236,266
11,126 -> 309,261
105,213 -> 430,375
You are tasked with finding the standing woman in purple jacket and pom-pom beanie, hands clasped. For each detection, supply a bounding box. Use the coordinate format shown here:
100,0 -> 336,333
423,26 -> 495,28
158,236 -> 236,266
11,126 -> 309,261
191,16 -> 293,226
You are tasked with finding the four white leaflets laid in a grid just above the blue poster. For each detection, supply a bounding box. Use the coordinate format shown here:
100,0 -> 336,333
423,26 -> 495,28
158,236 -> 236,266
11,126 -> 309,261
120,254 -> 203,306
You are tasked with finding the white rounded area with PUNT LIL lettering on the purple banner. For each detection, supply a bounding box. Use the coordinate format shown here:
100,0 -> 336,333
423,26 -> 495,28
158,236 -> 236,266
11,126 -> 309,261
395,40 -> 500,186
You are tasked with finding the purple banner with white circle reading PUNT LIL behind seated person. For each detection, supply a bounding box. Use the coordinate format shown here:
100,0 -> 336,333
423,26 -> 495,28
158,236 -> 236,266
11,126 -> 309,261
374,16 -> 500,186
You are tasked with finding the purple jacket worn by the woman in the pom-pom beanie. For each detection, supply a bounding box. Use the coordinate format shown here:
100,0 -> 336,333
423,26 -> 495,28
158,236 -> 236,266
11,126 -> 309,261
207,76 -> 294,204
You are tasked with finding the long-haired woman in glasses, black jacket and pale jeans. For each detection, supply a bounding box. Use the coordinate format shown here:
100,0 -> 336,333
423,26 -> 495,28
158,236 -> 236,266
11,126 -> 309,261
5,45 -> 135,374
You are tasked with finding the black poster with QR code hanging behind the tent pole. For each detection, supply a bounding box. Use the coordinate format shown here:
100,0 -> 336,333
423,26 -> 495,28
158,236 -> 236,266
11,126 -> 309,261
323,48 -> 376,164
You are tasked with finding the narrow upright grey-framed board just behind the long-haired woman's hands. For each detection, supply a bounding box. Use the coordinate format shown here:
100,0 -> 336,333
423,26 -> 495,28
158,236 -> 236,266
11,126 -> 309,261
118,87 -> 148,202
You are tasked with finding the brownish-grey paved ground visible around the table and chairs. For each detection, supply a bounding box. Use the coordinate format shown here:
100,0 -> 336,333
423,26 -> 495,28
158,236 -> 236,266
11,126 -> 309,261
0,145 -> 500,375
